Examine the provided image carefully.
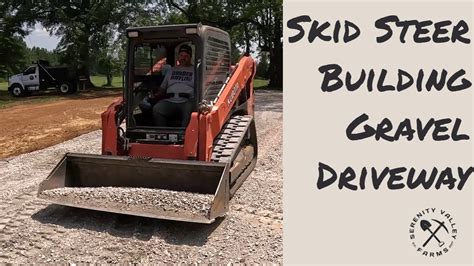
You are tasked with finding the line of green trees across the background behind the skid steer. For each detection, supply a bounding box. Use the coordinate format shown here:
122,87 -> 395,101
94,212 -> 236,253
0,0 -> 283,88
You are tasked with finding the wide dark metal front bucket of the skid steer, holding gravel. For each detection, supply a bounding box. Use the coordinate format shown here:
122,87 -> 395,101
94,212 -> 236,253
38,153 -> 229,224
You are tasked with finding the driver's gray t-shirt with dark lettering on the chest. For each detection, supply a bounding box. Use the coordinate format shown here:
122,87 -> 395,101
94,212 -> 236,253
160,66 -> 194,103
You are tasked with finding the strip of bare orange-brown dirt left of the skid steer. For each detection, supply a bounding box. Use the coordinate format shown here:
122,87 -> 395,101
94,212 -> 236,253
0,92 -> 120,158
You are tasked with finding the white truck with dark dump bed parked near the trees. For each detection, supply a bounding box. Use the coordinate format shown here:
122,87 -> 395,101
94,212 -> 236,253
8,60 -> 77,97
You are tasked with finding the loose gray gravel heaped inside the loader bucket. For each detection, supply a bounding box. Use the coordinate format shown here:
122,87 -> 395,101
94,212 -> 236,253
41,187 -> 213,217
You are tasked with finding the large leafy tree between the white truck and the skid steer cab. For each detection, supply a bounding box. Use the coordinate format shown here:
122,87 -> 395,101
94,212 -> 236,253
35,0 -> 156,86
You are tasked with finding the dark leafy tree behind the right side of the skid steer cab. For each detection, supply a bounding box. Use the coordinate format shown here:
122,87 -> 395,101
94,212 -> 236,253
166,0 -> 283,88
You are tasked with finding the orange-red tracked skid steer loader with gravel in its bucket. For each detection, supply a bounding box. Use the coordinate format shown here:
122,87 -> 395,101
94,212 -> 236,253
38,24 -> 257,223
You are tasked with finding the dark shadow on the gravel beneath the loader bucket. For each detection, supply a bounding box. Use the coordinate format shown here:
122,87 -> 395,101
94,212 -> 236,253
31,204 -> 224,246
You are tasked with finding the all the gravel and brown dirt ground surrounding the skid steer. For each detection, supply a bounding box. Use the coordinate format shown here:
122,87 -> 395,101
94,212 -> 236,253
0,91 -> 283,264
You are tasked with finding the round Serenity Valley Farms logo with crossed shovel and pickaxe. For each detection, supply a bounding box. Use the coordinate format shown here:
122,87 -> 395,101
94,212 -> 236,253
409,208 -> 458,257
